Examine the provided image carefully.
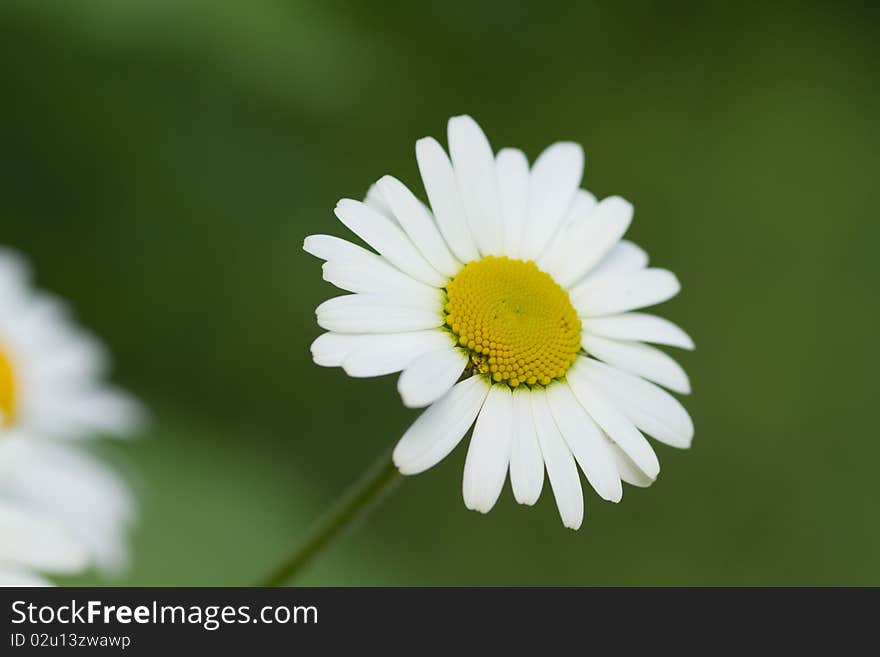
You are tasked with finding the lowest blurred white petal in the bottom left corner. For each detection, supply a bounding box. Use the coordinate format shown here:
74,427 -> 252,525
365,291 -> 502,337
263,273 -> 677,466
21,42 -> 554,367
0,501 -> 88,573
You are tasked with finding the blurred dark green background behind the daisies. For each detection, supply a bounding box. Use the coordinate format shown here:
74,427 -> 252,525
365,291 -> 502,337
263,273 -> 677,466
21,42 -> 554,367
0,0 -> 880,585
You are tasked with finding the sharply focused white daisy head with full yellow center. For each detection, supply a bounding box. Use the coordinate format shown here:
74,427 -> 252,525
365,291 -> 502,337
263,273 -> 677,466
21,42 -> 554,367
304,116 -> 694,529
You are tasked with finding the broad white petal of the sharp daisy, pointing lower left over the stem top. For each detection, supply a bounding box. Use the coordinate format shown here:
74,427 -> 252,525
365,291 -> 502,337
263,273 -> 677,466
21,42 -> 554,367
393,376 -> 489,475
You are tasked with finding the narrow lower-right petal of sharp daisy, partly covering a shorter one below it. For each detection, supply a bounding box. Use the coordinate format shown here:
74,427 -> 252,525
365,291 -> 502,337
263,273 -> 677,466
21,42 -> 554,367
567,358 -> 660,479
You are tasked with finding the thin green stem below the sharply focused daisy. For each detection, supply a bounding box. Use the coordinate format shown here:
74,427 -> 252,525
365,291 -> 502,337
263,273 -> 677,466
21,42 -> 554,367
260,453 -> 401,586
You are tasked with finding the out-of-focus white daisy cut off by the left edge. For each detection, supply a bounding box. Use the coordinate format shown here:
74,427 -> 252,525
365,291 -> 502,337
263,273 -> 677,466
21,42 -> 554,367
0,249 -> 142,586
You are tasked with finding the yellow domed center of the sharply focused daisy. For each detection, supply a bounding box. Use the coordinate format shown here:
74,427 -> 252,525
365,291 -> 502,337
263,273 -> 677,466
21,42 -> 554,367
446,256 -> 581,388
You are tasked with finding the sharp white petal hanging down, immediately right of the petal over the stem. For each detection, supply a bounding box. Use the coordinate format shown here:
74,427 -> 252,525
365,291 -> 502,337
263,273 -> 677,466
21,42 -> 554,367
462,385 -> 513,513
